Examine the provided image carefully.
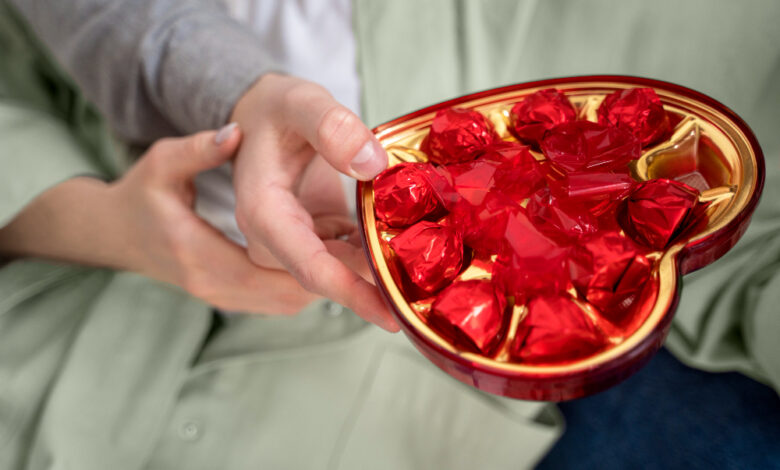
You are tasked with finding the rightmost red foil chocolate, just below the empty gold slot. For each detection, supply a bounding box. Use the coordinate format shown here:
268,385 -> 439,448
619,179 -> 699,250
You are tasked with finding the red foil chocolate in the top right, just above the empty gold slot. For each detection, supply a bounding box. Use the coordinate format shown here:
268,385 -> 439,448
598,88 -> 670,147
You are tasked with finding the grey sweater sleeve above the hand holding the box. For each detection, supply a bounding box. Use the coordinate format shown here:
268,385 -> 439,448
12,0 -> 274,143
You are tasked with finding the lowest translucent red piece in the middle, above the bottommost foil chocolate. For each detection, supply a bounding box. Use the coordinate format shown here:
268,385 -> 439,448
493,209 -> 569,299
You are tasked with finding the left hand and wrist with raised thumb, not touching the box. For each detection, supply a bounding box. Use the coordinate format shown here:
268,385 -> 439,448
0,126 -> 317,314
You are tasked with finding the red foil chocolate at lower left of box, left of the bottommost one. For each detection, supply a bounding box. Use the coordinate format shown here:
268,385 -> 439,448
429,281 -> 506,354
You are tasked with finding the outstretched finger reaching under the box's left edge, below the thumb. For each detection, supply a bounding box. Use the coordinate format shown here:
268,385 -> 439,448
250,187 -> 398,331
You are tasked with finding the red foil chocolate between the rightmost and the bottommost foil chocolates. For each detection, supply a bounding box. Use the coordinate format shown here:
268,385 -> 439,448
569,231 -> 652,324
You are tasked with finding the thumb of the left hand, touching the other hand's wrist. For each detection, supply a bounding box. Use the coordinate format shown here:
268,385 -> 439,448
150,123 -> 241,182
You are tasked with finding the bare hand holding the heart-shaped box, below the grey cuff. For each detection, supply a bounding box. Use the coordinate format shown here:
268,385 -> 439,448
225,74 -> 398,331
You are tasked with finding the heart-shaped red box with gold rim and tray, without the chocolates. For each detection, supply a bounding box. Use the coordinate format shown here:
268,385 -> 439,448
357,76 -> 764,401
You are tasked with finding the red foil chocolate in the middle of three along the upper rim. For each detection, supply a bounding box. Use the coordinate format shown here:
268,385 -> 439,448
509,88 -> 577,145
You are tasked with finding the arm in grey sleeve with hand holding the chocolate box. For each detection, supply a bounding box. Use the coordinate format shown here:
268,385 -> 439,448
14,0 -> 398,330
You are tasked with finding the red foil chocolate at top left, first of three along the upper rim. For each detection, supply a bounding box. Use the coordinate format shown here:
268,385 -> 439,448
420,108 -> 499,165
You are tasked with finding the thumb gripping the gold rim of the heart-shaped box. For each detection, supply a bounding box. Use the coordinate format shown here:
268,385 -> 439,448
285,84 -> 387,180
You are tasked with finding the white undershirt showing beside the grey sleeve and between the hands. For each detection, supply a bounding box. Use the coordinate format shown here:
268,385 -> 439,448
195,0 -> 360,244
